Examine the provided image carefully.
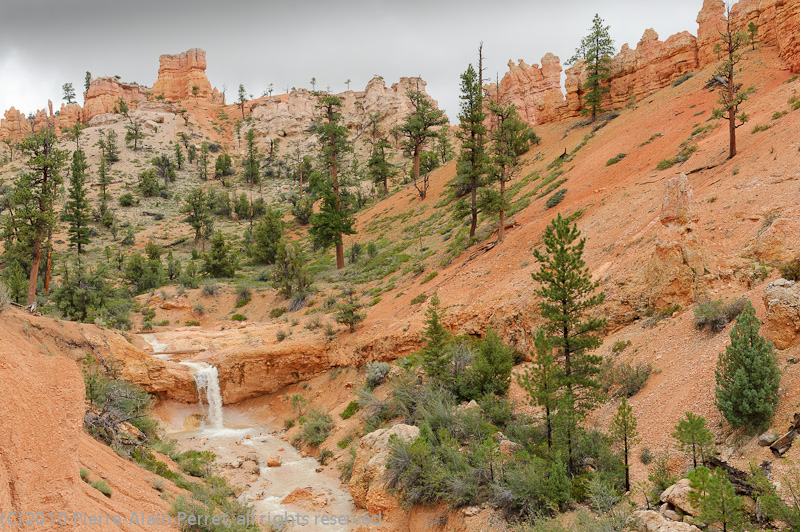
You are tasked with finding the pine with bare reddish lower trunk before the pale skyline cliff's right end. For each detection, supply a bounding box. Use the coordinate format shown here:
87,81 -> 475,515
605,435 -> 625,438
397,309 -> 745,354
398,86 -> 447,200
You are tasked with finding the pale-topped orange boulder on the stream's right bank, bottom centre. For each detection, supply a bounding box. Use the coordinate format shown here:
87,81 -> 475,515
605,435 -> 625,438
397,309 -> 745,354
349,424 -> 419,515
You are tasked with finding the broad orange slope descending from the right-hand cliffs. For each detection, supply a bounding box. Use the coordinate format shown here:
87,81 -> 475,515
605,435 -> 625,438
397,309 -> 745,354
332,47 -> 800,474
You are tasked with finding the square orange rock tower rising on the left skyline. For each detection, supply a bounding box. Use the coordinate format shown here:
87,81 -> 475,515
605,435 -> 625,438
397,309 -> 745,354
153,48 -> 225,105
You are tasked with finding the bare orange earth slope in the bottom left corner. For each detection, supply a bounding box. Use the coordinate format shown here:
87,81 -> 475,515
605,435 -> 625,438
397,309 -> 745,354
0,310 -> 192,531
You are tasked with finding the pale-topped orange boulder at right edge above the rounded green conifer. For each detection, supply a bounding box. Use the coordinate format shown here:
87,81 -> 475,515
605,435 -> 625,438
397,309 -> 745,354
763,279 -> 800,349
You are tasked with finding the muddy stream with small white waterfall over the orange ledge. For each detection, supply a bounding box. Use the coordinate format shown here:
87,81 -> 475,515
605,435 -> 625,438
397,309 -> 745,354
141,334 -> 364,532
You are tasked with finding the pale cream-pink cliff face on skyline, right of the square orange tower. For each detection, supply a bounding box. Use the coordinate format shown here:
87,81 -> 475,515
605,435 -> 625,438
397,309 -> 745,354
250,77 -> 436,139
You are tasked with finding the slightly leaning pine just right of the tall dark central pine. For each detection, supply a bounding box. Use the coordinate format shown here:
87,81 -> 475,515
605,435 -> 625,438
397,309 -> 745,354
489,98 -> 535,243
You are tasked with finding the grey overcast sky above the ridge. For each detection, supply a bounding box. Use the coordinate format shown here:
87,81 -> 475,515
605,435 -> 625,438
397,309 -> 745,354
0,0 -> 702,122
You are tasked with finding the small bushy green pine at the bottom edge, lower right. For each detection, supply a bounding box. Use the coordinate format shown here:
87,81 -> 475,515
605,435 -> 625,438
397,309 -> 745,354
689,466 -> 745,532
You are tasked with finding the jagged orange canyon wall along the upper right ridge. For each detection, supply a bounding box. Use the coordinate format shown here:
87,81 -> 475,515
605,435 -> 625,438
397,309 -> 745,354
500,0 -> 800,125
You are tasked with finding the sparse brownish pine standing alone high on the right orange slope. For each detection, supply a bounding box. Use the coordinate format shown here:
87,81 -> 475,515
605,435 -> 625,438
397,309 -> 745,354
711,6 -> 755,159
